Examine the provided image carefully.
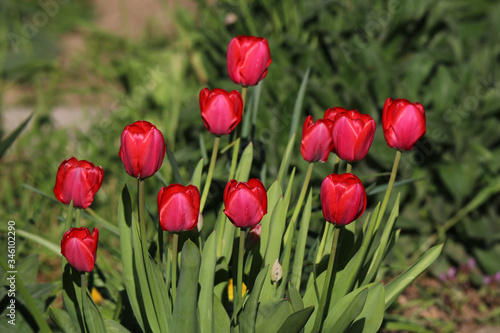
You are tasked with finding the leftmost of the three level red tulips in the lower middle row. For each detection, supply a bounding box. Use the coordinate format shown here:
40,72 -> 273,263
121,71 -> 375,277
158,184 -> 200,232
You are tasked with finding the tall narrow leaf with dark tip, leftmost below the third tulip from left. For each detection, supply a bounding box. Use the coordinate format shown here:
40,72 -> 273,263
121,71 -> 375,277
118,185 -> 145,331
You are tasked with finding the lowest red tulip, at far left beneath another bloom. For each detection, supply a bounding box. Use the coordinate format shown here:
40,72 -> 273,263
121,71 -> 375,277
61,227 -> 99,272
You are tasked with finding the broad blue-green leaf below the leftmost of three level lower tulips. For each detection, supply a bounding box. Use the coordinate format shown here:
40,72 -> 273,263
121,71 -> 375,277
170,240 -> 201,333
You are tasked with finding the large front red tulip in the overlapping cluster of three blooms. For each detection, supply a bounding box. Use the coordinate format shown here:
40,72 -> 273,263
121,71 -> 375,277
332,110 -> 376,162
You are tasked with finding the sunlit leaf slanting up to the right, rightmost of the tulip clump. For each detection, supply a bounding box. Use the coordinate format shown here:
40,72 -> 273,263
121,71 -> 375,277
385,244 -> 443,309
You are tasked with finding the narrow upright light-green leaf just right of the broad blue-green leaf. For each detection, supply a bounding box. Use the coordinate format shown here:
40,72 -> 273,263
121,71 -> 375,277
198,232 -> 217,333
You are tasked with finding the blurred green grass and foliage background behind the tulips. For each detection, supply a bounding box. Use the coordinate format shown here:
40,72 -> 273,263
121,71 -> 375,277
0,0 -> 500,332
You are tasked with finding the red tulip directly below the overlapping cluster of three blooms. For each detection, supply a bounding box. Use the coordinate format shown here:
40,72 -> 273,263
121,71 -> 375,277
320,173 -> 366,225
